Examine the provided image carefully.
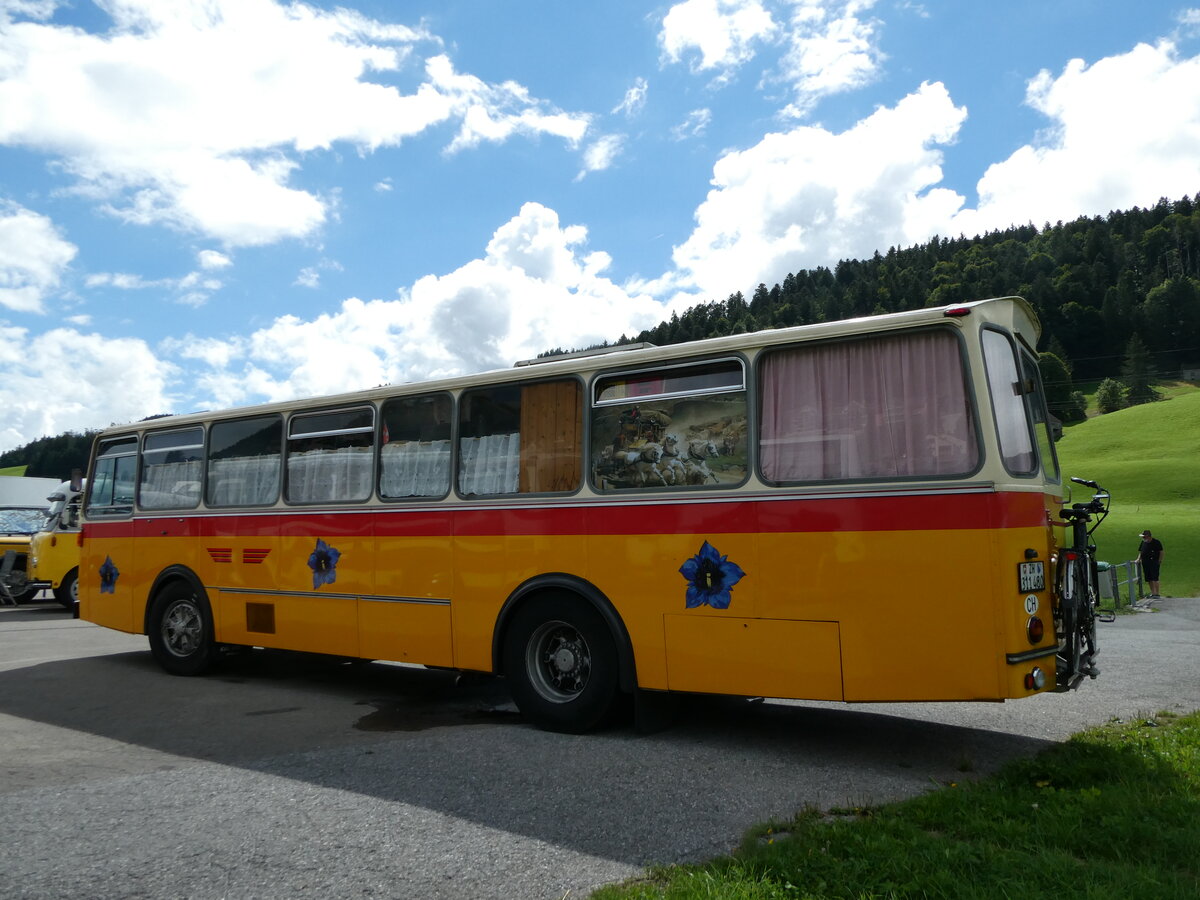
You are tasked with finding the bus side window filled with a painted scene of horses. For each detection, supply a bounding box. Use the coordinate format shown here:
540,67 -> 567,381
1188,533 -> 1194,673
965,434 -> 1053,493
592,360 -> 746,491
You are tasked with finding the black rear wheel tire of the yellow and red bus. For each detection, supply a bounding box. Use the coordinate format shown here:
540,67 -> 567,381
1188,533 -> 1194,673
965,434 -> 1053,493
503,593 -> 618,734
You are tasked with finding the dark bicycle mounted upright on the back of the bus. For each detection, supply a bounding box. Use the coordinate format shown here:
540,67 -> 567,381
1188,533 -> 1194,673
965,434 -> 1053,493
1055,478 -> 1115,691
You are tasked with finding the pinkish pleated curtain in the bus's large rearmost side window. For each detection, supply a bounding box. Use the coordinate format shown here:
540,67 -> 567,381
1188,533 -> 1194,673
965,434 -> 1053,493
761,331 -> 978,481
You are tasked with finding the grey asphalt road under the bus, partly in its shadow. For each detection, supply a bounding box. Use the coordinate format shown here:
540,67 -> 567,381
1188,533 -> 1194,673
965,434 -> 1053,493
0,599 -> 1200,900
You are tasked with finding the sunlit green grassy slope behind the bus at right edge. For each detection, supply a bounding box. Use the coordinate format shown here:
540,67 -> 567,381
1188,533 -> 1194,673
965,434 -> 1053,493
1057,391 -> 1200,596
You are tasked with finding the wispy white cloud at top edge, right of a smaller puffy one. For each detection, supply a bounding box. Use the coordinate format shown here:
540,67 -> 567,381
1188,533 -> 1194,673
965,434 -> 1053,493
780,0 -> 883,116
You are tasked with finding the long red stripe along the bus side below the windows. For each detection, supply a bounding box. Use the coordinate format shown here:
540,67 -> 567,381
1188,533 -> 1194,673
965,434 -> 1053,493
88,492 -> 1046,539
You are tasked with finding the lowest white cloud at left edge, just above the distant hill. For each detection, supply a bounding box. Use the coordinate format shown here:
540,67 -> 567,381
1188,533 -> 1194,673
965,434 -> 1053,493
0,323 -> 178,448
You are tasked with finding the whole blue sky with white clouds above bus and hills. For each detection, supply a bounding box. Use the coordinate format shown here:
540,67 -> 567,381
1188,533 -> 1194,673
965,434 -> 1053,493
0,0 -> 1200,450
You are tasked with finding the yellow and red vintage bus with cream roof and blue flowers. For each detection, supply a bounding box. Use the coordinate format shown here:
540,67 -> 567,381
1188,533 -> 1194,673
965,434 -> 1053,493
79,298 -> 1080,731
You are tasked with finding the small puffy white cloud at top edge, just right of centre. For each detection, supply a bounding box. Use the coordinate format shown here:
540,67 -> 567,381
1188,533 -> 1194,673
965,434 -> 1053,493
659,0 -> 776,72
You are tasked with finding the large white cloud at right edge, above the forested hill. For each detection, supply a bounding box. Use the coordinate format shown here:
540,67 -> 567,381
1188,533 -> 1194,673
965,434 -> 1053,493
953,42 -> 1200,234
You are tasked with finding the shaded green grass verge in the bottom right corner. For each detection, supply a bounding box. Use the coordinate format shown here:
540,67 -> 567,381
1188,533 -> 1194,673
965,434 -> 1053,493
592,713 -> 1200,900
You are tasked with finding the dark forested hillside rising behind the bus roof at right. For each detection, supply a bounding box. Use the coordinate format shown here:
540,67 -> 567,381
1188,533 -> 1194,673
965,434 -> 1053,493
622,197 -> 1200,379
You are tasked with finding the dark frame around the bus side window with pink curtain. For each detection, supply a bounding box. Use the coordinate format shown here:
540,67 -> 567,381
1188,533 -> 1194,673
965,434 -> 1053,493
754,323 -> 988,487
